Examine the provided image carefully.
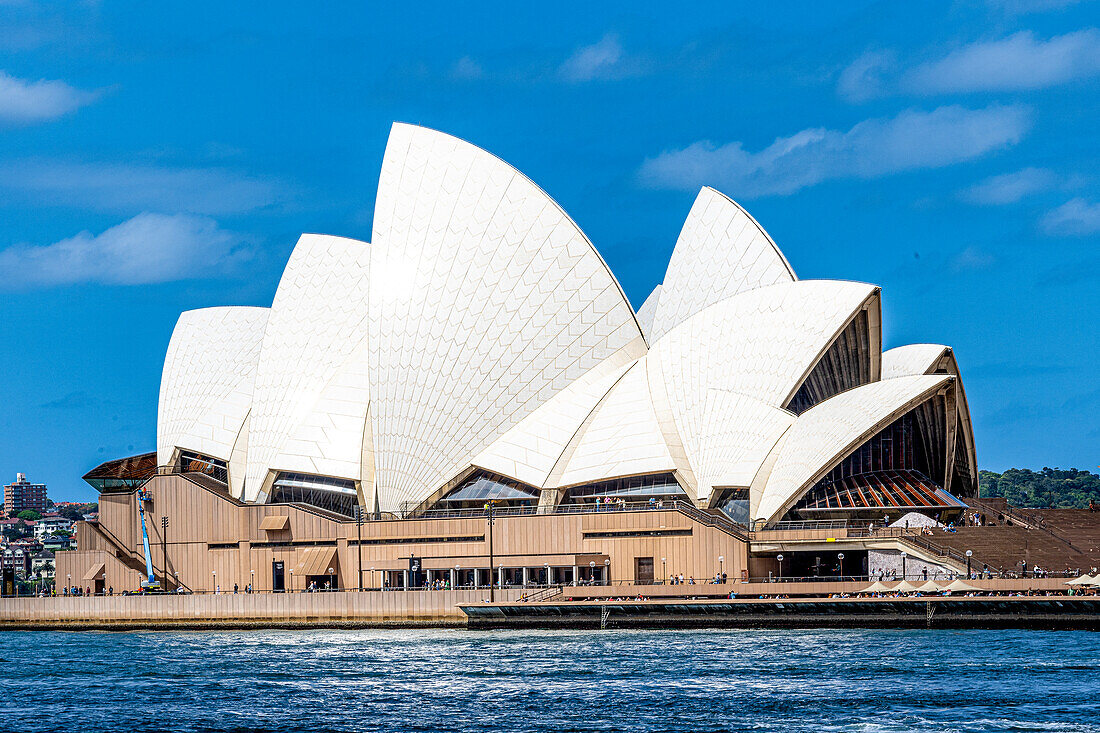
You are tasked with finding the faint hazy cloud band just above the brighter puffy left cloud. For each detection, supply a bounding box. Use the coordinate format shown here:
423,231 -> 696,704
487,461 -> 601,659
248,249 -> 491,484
0,160 -> 286,216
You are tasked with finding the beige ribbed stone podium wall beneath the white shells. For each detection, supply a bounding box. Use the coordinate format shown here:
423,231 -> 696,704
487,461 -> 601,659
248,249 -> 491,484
57,475 -> 748,592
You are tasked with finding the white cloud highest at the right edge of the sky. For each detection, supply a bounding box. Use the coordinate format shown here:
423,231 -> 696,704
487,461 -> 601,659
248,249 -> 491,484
902,29 -> 1100,94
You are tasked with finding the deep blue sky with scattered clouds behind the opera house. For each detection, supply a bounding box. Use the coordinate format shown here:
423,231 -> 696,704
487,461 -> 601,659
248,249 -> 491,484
0,0 -> 1100,500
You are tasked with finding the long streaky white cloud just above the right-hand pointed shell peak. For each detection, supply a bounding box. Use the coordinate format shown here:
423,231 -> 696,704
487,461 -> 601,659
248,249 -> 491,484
638,105 -> 1030,198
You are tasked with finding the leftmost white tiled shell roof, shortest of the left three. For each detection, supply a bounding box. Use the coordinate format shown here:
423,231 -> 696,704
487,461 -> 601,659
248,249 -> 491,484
156,307 -> 268,490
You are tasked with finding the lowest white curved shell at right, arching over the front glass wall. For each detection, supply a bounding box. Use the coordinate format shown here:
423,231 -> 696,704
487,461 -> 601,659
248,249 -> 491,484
750,375 -> 954,523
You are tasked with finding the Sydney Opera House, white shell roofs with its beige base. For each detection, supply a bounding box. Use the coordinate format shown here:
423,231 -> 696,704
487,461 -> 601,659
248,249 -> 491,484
58,124 -> 977,590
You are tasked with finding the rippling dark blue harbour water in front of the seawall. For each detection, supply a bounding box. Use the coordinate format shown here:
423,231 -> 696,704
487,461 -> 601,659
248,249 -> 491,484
0,630 -> 1100,733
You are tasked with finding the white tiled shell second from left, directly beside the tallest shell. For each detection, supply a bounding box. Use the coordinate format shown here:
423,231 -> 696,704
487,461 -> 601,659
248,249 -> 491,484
244,234 -> 371,501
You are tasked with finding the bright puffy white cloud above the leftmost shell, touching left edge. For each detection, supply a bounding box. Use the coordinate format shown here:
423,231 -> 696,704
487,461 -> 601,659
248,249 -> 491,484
0,214 -> 248,287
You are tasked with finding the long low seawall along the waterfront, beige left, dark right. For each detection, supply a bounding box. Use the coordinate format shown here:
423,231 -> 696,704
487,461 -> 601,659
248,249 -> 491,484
0,578 -> 1100,631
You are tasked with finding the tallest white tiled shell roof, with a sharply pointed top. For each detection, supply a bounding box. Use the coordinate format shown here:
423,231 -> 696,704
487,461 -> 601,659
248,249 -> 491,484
369,124 -> 641,510
